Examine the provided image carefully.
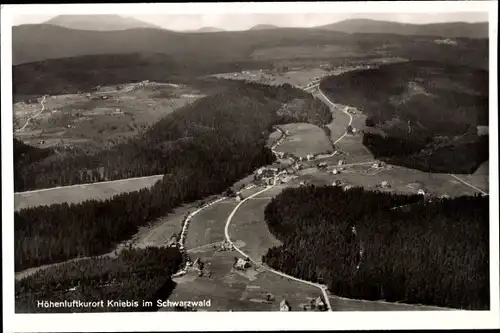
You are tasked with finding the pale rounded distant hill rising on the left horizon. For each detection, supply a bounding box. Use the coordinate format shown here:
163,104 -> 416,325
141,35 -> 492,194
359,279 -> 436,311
44,15 -> 162,31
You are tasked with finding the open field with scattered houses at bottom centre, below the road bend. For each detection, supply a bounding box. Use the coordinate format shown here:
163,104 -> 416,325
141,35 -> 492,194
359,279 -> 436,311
162,248 -> 320,311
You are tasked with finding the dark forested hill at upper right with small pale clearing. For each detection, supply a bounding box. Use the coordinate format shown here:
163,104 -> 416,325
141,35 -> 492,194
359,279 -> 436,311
321,61 -> 489,173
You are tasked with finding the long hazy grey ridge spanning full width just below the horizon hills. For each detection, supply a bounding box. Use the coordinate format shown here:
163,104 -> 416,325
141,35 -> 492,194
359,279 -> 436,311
12,24 -> 488,68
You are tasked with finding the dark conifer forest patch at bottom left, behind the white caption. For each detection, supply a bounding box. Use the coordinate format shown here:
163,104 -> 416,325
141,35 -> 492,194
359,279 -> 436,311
15,247 -> 182,313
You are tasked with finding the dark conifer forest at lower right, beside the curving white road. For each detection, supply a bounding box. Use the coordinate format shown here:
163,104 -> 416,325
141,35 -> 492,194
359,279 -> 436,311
263,186 -> 490,310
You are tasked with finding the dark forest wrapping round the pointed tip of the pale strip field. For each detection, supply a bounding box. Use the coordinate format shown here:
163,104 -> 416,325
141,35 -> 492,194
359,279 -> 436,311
14,80 -> 331,271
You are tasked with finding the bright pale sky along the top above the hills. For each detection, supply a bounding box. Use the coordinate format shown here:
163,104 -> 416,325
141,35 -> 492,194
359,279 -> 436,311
13,12 -> 488,31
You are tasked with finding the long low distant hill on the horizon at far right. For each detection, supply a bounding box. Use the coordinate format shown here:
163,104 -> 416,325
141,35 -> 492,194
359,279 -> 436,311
316,19 -> 488,38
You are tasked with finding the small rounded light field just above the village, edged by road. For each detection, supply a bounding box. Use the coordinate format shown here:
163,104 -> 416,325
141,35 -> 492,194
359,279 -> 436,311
276,123 -> 333,157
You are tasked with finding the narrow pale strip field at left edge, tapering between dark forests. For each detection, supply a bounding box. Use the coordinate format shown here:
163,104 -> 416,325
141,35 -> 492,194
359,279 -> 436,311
14,175 -> 163,211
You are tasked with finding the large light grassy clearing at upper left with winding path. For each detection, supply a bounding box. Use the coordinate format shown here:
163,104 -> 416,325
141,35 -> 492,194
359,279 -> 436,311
14,83 -> 203,151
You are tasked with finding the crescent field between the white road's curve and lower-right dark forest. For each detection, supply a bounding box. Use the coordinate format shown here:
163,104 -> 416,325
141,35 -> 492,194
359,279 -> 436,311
229,196 -> 282,262
